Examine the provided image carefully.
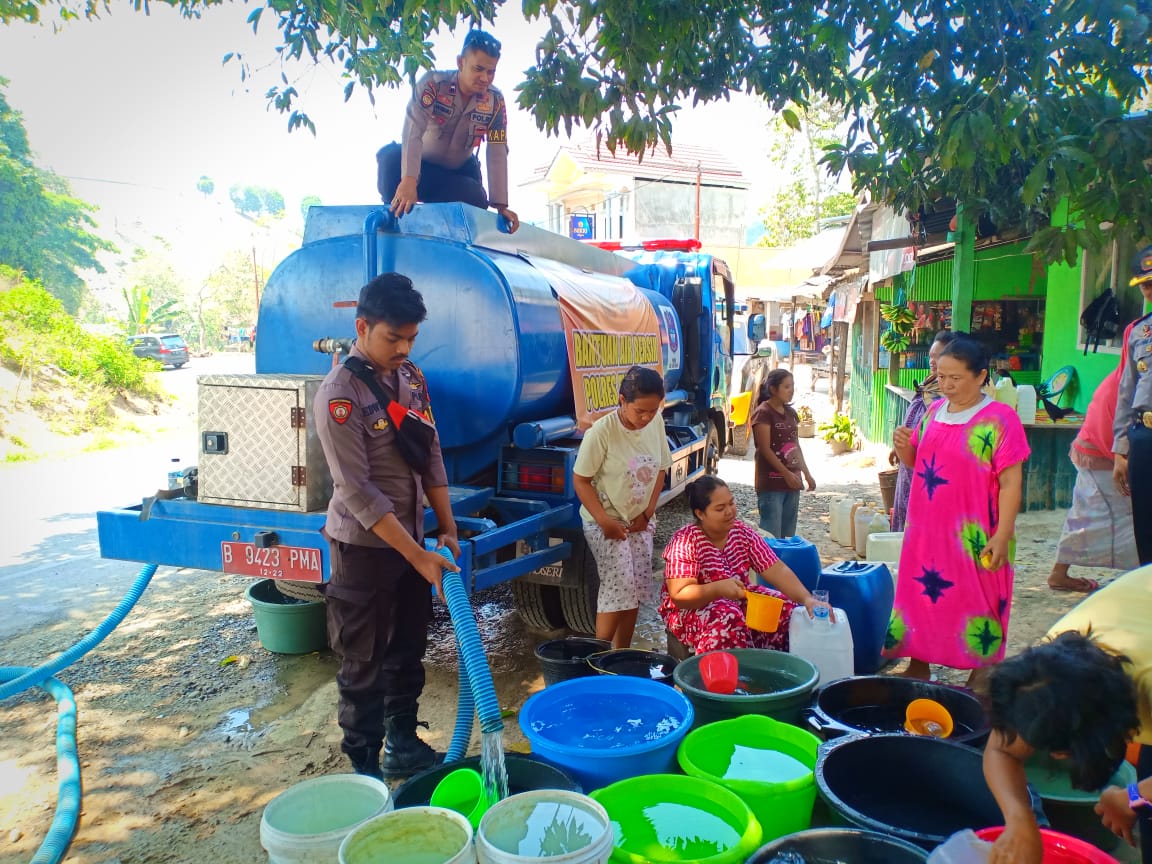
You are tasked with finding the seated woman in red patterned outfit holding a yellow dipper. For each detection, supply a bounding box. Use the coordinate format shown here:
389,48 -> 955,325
660,476 -> 817,654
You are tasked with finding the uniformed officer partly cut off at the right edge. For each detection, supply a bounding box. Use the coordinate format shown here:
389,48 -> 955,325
1112,247 -> 1152,564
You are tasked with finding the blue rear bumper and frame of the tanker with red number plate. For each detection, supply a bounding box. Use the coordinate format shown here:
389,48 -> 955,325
97,486 -> 575,591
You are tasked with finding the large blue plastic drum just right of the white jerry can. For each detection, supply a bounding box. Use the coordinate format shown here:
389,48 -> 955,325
804,561 -> 896,675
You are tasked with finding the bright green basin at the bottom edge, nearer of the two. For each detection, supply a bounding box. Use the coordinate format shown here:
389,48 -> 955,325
592,774 -> 761,864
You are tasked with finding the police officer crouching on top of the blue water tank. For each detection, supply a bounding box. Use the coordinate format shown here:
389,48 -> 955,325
376,30 -> 520,232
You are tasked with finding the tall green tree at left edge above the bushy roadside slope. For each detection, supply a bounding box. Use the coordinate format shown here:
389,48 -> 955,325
0,77 -> 114,314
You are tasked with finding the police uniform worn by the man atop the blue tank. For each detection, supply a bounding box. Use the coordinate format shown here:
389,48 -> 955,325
376,70 -> 508,210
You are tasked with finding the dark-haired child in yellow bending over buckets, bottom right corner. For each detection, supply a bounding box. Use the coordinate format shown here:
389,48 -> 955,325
984,567 -> 1152,864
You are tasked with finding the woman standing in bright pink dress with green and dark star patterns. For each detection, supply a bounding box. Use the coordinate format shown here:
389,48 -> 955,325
884,338 -> 1029,685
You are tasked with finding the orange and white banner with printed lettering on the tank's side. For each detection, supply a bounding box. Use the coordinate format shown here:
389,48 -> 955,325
532,259 -> 664,429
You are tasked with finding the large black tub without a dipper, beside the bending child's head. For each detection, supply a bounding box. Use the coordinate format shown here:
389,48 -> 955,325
816,735 -> 1003,850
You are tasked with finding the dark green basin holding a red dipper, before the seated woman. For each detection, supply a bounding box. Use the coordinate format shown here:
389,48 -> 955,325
672,649 -> 820,726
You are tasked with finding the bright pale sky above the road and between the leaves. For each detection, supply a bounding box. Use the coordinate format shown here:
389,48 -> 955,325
0,3 -> 763,220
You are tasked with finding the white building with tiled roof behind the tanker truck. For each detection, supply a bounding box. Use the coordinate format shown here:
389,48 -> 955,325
521,141 -> 749,247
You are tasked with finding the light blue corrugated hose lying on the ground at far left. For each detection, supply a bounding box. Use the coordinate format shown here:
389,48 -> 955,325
0,564 -> 160,864
